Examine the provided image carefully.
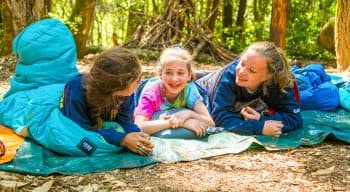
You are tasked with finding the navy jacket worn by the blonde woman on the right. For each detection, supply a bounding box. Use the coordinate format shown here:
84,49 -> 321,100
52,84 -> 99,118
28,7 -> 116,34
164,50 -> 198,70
197,59 -> 302,135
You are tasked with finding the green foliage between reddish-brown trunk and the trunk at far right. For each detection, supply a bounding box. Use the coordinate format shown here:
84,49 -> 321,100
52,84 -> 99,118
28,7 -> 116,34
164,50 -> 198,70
286,0 -> 336,59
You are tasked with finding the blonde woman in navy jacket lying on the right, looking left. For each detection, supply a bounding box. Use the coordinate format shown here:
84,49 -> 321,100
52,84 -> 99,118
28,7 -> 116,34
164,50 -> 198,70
197,42 -> 302,137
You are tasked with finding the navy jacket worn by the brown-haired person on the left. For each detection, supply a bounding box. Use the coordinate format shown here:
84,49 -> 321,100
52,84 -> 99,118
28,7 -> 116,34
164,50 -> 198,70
61,75 -> 140,145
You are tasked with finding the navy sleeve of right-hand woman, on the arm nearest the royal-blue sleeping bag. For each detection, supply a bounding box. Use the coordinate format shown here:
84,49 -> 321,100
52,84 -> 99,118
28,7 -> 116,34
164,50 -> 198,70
264,88 -> 303,132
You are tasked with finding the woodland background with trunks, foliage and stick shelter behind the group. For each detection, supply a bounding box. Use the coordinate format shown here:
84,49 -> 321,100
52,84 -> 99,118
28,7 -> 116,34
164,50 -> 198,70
0,0 -> 350,72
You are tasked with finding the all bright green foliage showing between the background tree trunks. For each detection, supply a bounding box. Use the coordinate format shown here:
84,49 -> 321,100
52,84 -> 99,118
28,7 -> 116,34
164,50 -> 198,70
43,0 -> 336,59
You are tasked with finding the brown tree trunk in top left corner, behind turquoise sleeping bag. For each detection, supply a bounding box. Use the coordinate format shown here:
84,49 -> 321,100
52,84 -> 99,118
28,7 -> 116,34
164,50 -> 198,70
0,0 -> 51,55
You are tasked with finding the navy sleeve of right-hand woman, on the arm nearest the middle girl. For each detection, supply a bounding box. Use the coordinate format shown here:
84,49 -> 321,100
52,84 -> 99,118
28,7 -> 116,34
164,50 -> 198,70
211,64 -> 265,135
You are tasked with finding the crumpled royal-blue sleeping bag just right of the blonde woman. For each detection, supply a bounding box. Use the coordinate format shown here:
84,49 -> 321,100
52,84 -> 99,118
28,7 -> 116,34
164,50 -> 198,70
292,64 -> 339,110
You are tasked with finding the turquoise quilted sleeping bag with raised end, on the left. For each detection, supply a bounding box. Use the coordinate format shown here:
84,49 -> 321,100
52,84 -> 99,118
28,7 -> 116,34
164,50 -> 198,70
0,19 -> 123,156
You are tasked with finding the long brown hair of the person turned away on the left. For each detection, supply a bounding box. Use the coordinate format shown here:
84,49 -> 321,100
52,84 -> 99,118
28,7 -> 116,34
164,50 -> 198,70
83,48 -> 141,128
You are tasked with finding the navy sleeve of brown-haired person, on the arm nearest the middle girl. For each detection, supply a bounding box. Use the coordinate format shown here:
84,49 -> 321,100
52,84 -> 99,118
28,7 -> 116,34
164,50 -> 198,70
116,94 -> 141,133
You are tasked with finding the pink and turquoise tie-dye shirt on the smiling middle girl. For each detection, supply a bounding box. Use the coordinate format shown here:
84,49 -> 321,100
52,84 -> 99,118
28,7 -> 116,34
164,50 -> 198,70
134,78 -> 203,119
